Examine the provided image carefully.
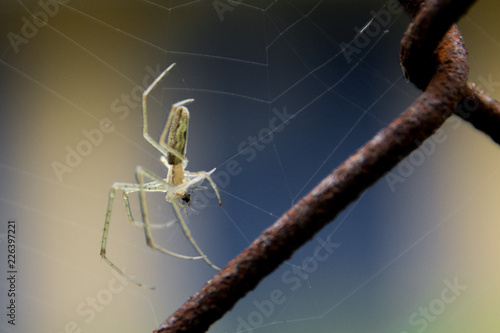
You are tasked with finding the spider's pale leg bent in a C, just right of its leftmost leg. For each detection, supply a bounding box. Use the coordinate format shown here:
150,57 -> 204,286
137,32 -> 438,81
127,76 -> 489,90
135,166 -> 204,260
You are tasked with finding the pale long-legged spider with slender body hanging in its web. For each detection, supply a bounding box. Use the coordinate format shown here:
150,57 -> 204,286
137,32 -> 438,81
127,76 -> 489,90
101,63 -> 221,289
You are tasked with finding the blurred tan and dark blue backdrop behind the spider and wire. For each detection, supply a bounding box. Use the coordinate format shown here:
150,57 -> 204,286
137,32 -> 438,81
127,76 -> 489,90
0,0 -> 500,333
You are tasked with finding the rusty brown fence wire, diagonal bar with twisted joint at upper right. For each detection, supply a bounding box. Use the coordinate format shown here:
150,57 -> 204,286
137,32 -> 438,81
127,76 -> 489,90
154,0 -> 500,333
